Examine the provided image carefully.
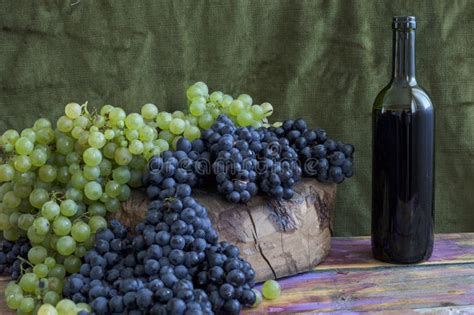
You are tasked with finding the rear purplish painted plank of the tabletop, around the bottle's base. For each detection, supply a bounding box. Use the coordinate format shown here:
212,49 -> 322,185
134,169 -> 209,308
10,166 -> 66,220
316,233 -> 474,270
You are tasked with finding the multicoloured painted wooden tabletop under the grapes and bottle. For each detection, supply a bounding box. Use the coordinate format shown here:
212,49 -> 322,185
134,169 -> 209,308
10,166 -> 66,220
0,233 -> 474,315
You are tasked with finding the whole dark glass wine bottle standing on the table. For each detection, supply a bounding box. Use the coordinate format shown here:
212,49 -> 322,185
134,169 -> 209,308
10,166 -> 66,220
372,16 -> 434,263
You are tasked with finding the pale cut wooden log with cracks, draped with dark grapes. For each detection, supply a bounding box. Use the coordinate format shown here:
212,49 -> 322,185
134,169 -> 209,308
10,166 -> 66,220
115,179 -> 336,281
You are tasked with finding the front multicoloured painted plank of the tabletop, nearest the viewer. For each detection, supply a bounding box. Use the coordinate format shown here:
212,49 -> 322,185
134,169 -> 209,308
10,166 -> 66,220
244,264 -> 474,314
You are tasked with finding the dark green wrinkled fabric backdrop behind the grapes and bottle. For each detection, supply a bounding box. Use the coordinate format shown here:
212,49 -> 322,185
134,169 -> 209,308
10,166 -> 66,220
0,0 -> 474,235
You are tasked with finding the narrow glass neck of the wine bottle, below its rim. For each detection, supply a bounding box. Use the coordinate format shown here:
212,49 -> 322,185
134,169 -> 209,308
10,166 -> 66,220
392,29 -> 416,85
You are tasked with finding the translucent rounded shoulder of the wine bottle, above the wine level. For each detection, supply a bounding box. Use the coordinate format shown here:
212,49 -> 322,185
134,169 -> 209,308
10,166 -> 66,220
373,82 -> 433,111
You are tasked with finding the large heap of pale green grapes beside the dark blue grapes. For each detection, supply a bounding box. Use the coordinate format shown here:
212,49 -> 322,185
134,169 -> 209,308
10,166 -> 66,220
0,82 -> 273,314
